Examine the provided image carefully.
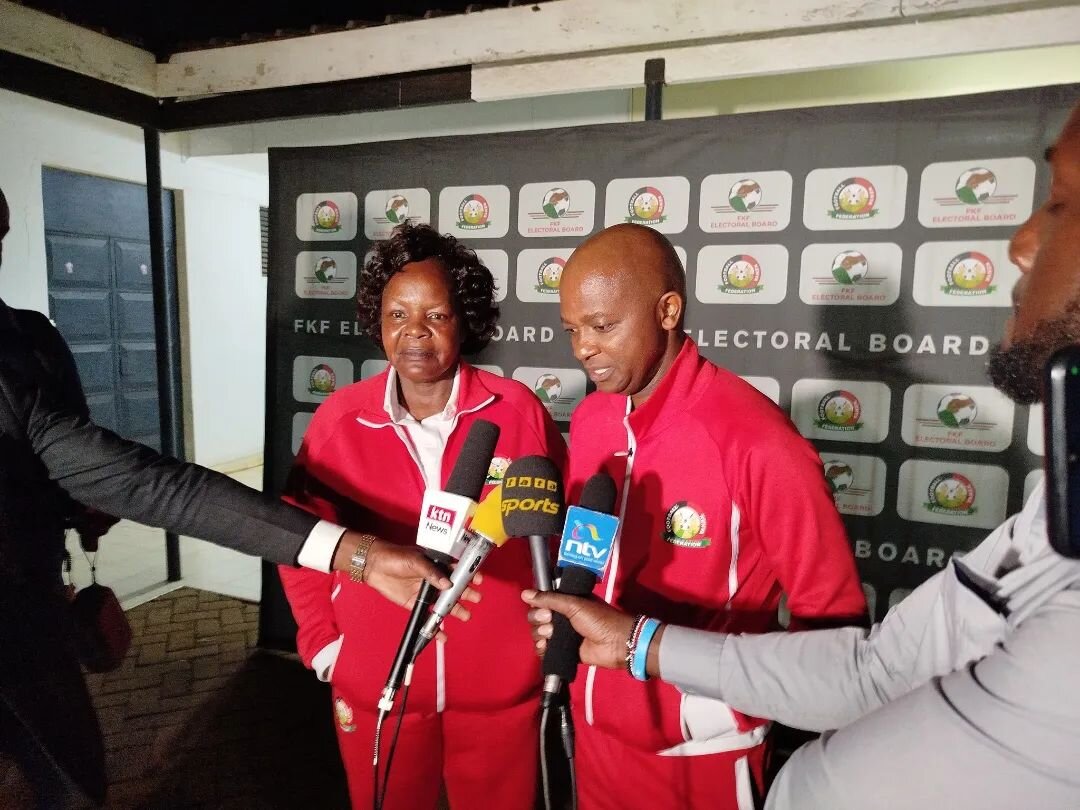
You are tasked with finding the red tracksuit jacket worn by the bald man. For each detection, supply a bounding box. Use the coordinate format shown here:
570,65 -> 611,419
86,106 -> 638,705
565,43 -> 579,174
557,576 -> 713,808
568,339 -> 866,754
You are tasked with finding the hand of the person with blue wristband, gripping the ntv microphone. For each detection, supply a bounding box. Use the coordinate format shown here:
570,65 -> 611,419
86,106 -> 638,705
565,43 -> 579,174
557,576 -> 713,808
522,591 -> 634,670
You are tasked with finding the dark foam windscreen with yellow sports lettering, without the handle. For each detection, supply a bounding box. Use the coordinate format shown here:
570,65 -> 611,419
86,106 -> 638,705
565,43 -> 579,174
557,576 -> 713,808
502,456 -> 564,537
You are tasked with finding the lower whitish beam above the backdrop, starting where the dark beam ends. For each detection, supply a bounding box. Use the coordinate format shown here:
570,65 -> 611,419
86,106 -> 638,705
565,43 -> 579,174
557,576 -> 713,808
473,4 -> 1080,102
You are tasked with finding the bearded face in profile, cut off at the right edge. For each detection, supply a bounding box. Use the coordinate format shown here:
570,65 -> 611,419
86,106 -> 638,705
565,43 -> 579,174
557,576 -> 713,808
988,108 -> 1080,404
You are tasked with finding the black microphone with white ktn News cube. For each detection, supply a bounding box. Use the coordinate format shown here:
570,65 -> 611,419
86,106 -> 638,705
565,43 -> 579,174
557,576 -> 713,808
379,419 -> 499,712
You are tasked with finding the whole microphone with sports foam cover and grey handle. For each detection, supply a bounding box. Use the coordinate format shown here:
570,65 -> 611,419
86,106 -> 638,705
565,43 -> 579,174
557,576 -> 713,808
502,456 -> 565,591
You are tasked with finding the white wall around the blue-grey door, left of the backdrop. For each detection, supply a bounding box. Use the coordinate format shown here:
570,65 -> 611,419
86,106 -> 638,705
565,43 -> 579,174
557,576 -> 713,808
0,91 -> 267,465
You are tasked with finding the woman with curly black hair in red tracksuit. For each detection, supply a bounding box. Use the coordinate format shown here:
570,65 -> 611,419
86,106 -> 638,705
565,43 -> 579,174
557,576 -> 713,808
281,225 -> 566,810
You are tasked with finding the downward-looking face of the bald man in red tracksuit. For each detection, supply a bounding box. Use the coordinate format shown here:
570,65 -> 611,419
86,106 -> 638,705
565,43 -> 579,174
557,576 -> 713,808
559,264 -> 667,396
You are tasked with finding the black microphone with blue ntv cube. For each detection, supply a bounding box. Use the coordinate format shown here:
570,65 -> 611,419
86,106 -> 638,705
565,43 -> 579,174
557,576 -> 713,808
543,473 -> 619,706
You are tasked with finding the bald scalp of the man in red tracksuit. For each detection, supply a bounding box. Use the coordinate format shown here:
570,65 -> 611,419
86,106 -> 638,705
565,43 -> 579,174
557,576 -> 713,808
559,222 -> 686,315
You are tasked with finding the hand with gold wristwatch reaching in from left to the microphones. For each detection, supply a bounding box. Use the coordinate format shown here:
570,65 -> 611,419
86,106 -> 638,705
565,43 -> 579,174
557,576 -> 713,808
334,531 -> 482,621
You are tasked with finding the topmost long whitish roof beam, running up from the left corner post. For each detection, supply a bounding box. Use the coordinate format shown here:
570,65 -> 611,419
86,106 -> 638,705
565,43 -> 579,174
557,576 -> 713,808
158,0 -> 1054,97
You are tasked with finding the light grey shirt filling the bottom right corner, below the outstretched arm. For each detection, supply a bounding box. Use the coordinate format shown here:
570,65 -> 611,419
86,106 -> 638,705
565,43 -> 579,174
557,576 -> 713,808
766,591 -> 1080,810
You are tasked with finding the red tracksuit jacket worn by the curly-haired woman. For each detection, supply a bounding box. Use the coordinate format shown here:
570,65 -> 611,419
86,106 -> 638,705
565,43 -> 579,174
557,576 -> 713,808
280,363 -> 566,713
